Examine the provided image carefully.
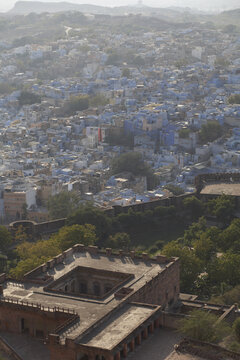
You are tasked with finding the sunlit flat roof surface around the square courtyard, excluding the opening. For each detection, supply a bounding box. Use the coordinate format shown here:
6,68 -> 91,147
3,251 -> 174,346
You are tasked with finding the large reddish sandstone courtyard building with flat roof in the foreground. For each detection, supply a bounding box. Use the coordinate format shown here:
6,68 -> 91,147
0,245 -> 179,360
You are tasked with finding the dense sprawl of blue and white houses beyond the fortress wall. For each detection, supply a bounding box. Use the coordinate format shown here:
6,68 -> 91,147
0,4 -> 240,222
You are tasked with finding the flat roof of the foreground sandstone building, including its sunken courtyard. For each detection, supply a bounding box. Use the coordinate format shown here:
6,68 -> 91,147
2,245 -> 175,349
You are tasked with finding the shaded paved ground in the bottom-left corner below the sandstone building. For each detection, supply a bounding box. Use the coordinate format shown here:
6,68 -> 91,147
0,332 -> 50,360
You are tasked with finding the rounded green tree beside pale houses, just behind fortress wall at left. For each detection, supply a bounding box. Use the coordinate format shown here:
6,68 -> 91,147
47,191 -> 78,219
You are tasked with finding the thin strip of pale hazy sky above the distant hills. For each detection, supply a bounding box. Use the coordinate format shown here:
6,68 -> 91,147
0,0 -> 240,11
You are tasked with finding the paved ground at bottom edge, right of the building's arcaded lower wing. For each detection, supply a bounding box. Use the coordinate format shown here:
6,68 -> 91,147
128,329 -> 182,360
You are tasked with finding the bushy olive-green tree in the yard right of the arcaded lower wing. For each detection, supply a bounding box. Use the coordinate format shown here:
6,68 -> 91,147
179,310 -> 231,343
